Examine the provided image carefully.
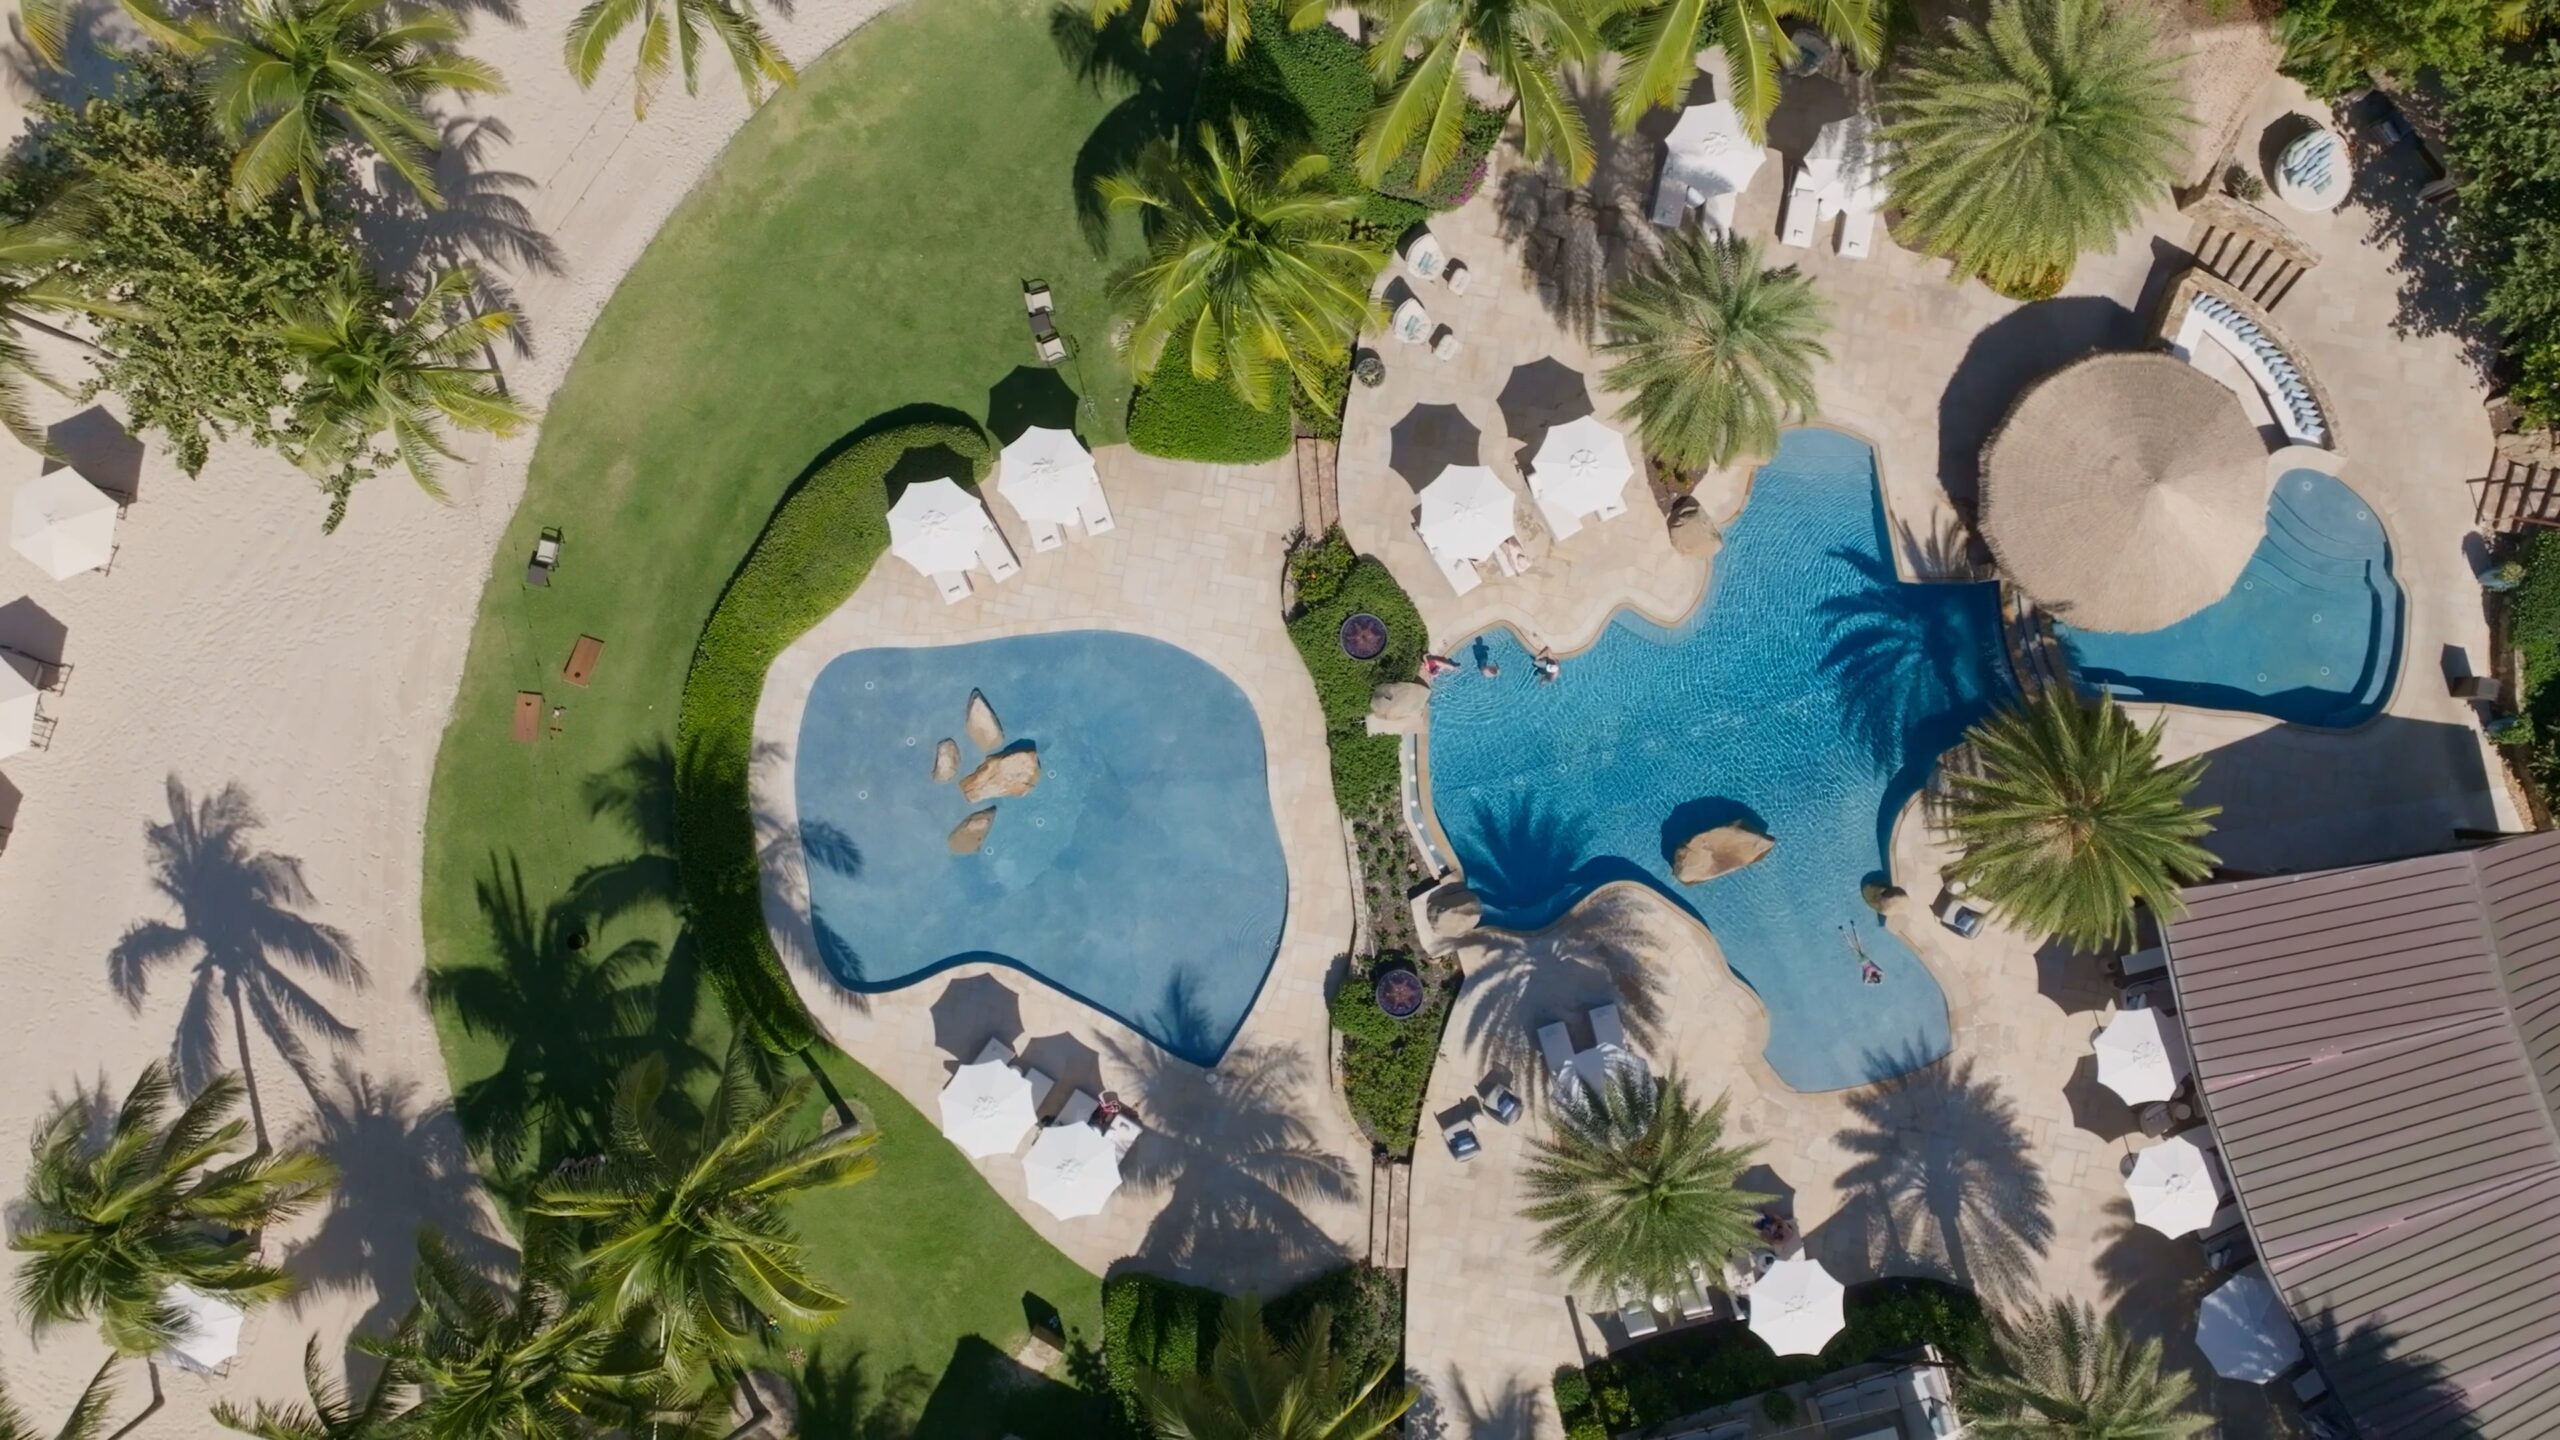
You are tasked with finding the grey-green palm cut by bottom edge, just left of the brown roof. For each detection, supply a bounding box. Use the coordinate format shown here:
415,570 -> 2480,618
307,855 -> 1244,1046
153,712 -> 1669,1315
1964,1299 -> 2214,1440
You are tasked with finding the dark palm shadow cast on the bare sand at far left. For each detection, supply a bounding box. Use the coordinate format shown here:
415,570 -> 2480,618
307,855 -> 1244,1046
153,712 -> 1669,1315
108,774 -> 369,1145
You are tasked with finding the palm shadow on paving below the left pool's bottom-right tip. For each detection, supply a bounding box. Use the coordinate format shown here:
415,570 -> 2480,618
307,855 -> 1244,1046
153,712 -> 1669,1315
1106,1038 -> 1359,1289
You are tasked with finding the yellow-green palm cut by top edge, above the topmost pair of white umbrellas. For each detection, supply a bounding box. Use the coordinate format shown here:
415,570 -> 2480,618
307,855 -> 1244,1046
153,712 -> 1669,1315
1613,0 -> 1884,136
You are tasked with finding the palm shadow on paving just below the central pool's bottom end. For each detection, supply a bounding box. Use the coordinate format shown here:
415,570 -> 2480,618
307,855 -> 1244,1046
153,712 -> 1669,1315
1823,1053 -> 2053,1302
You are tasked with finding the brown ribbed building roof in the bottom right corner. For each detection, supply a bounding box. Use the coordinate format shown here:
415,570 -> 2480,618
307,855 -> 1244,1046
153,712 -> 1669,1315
2168,835 -> 2560,1440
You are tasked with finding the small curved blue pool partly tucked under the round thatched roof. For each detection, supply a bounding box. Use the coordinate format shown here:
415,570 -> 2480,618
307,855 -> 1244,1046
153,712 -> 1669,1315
2053,469 -> 2401,728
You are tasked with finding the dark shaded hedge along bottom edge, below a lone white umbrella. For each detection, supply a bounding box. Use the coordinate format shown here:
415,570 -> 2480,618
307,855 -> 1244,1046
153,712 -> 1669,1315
1554,1279 -> 1992,1435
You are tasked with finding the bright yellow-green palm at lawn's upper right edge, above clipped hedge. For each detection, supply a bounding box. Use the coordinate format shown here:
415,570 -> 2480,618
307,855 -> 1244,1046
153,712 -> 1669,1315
1096,118 -> 1385,410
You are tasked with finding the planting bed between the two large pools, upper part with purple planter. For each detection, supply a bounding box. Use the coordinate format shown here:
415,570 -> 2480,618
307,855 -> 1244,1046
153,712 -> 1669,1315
1288,530 -> 1428,815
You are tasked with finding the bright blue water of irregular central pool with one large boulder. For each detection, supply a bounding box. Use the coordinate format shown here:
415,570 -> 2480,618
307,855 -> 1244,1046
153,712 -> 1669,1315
1431,430 -> 2012,1089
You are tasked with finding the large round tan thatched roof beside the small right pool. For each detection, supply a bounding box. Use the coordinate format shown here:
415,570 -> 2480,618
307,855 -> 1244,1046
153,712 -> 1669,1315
1981,354 -> 2273,630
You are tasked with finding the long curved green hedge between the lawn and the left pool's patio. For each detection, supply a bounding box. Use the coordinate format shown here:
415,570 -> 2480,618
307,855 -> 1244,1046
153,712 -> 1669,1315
676,423 -> 993,1056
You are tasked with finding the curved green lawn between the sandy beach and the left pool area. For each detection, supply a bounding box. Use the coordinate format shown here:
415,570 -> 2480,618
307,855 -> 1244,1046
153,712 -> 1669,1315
425,0 -> 1129,1435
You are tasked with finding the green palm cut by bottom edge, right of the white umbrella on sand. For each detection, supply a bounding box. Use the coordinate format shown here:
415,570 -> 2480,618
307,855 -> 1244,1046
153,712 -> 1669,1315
358,1230 -> 666,1440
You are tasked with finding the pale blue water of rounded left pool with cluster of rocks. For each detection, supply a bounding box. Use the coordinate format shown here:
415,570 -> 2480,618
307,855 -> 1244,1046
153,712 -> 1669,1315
799,630 -> 1288,1066
